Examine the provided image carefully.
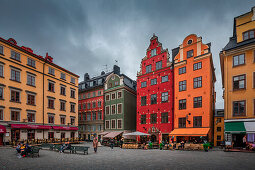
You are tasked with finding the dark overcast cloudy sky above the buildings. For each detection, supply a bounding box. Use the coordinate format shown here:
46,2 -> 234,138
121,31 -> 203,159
0,0 -> 255,108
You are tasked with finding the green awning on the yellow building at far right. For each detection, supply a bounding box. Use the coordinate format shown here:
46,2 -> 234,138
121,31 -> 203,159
225,122 -> 246,133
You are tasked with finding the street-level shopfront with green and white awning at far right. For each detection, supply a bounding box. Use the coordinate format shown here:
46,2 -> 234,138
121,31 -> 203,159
225,119 -> 255,148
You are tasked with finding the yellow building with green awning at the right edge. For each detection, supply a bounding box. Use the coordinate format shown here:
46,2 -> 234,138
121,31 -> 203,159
220,7 -> 255,147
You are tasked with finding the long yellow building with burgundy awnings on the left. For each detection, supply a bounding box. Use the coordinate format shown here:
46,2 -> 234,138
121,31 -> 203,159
0,38 -> 79,145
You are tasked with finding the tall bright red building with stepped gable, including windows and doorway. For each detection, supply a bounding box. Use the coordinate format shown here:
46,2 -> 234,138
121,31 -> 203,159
137,35 -> 173,142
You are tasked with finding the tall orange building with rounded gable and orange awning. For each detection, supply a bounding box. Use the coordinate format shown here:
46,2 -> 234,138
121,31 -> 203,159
170,34 -> 216,142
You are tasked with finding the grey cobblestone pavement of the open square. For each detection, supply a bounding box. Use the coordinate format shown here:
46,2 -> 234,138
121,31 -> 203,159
0,143 -> 255,170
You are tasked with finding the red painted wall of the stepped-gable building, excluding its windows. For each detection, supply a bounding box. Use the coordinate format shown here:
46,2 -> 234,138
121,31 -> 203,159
137,36 -> 173,135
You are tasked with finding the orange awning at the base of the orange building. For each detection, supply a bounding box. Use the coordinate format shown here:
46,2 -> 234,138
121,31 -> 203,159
170,128 -> 210,136
